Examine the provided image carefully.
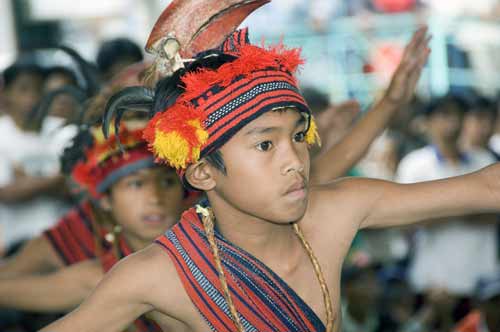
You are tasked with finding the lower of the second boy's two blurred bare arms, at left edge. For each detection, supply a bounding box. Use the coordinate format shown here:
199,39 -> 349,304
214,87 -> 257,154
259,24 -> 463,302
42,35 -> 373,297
0,259 -> 103,312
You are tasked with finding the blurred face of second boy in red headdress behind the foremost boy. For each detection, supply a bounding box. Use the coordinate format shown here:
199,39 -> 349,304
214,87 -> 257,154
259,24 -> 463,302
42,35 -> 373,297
104,167 -> 184,241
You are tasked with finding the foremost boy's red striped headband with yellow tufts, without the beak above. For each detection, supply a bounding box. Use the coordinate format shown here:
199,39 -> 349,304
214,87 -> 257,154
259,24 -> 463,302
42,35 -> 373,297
144,29 -> 317,170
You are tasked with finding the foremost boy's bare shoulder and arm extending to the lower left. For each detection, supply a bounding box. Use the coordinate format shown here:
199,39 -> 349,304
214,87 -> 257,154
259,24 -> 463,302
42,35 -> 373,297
41,245 -> 180,332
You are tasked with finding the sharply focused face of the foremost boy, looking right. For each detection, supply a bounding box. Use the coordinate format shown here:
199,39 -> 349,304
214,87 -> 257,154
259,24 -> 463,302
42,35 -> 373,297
209,109 -> 309,223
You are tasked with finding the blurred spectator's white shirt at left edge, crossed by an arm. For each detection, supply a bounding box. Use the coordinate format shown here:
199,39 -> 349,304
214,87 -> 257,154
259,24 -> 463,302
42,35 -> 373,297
0,116 -> 69,249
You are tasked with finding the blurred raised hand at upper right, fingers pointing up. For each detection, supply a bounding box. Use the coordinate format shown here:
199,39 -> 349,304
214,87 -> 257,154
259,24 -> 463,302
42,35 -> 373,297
384,26 -> 431,105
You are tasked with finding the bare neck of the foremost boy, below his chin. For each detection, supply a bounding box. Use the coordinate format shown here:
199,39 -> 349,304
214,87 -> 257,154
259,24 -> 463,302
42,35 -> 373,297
206,192 -> 303,268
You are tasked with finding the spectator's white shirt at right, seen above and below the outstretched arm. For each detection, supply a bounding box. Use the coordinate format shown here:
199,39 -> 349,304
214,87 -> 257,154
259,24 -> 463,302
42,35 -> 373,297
397,146 -> 498,295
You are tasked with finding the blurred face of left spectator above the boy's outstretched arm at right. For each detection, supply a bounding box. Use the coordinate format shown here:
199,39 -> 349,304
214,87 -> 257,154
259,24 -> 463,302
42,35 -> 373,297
428,104 -> 463,141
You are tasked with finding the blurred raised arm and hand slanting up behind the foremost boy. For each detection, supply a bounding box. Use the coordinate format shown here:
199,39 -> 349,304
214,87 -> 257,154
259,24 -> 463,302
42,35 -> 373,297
311,27 -> 430,184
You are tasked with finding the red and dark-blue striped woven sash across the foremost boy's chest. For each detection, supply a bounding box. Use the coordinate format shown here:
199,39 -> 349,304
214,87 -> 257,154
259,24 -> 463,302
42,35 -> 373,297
156,208 -> 325,332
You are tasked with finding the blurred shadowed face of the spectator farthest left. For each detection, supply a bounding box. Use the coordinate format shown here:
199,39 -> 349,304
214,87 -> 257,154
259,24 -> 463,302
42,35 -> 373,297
5,72 -> 43,118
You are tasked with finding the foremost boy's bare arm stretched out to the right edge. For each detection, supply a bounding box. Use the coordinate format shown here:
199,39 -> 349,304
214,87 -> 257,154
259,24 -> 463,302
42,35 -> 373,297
320,164 -> 500,228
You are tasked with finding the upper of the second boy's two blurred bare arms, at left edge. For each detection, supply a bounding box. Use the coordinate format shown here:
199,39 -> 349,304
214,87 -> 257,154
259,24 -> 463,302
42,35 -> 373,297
0,235 -> 64,280
